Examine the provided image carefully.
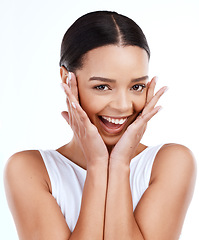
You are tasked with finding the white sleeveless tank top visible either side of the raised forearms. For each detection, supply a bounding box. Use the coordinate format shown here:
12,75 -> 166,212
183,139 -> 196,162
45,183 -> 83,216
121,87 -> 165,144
39,144 -> 163,232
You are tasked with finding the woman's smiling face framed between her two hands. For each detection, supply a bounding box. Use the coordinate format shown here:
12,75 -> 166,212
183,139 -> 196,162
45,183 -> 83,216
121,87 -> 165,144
76,45 -> 148,146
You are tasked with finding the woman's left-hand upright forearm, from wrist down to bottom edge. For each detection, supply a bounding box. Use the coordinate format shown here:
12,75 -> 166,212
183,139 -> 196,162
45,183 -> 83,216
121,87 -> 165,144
70,165 -> 107,240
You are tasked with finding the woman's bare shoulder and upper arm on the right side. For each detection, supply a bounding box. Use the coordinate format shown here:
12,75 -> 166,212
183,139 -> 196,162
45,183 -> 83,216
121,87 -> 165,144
135,144 -> 196,240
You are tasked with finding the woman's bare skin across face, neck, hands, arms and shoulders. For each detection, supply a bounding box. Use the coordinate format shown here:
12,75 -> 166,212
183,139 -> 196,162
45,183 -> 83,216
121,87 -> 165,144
5,46 -> 196,240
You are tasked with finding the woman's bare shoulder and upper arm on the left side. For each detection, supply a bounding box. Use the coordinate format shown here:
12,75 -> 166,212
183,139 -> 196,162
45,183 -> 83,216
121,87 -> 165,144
4,151 -> 70,240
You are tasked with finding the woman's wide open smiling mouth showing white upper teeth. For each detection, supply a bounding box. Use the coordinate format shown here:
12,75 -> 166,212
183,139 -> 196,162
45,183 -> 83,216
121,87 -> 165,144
99,116 -> 128,134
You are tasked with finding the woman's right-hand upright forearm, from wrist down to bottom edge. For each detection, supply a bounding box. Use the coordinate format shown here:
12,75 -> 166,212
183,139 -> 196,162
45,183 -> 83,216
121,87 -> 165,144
104,164 -> 144,240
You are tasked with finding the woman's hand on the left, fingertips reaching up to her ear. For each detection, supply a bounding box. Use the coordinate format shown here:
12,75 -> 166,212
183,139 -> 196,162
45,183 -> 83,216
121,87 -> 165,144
62,74 -> 108,169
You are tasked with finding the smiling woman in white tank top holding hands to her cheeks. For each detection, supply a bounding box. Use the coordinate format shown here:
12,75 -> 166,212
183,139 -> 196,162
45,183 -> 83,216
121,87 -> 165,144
5,11 -> 196,240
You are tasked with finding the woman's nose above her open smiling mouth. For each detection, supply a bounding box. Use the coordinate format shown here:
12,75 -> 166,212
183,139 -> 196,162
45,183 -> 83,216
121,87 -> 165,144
110,91 -> 133,114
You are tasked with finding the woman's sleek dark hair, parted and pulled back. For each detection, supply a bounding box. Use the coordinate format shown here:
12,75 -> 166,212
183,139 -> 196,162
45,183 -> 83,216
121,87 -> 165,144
59,11 -> 150,72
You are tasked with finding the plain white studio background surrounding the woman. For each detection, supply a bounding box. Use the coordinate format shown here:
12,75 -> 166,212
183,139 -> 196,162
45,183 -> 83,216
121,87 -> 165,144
0,0 -> 199,240
